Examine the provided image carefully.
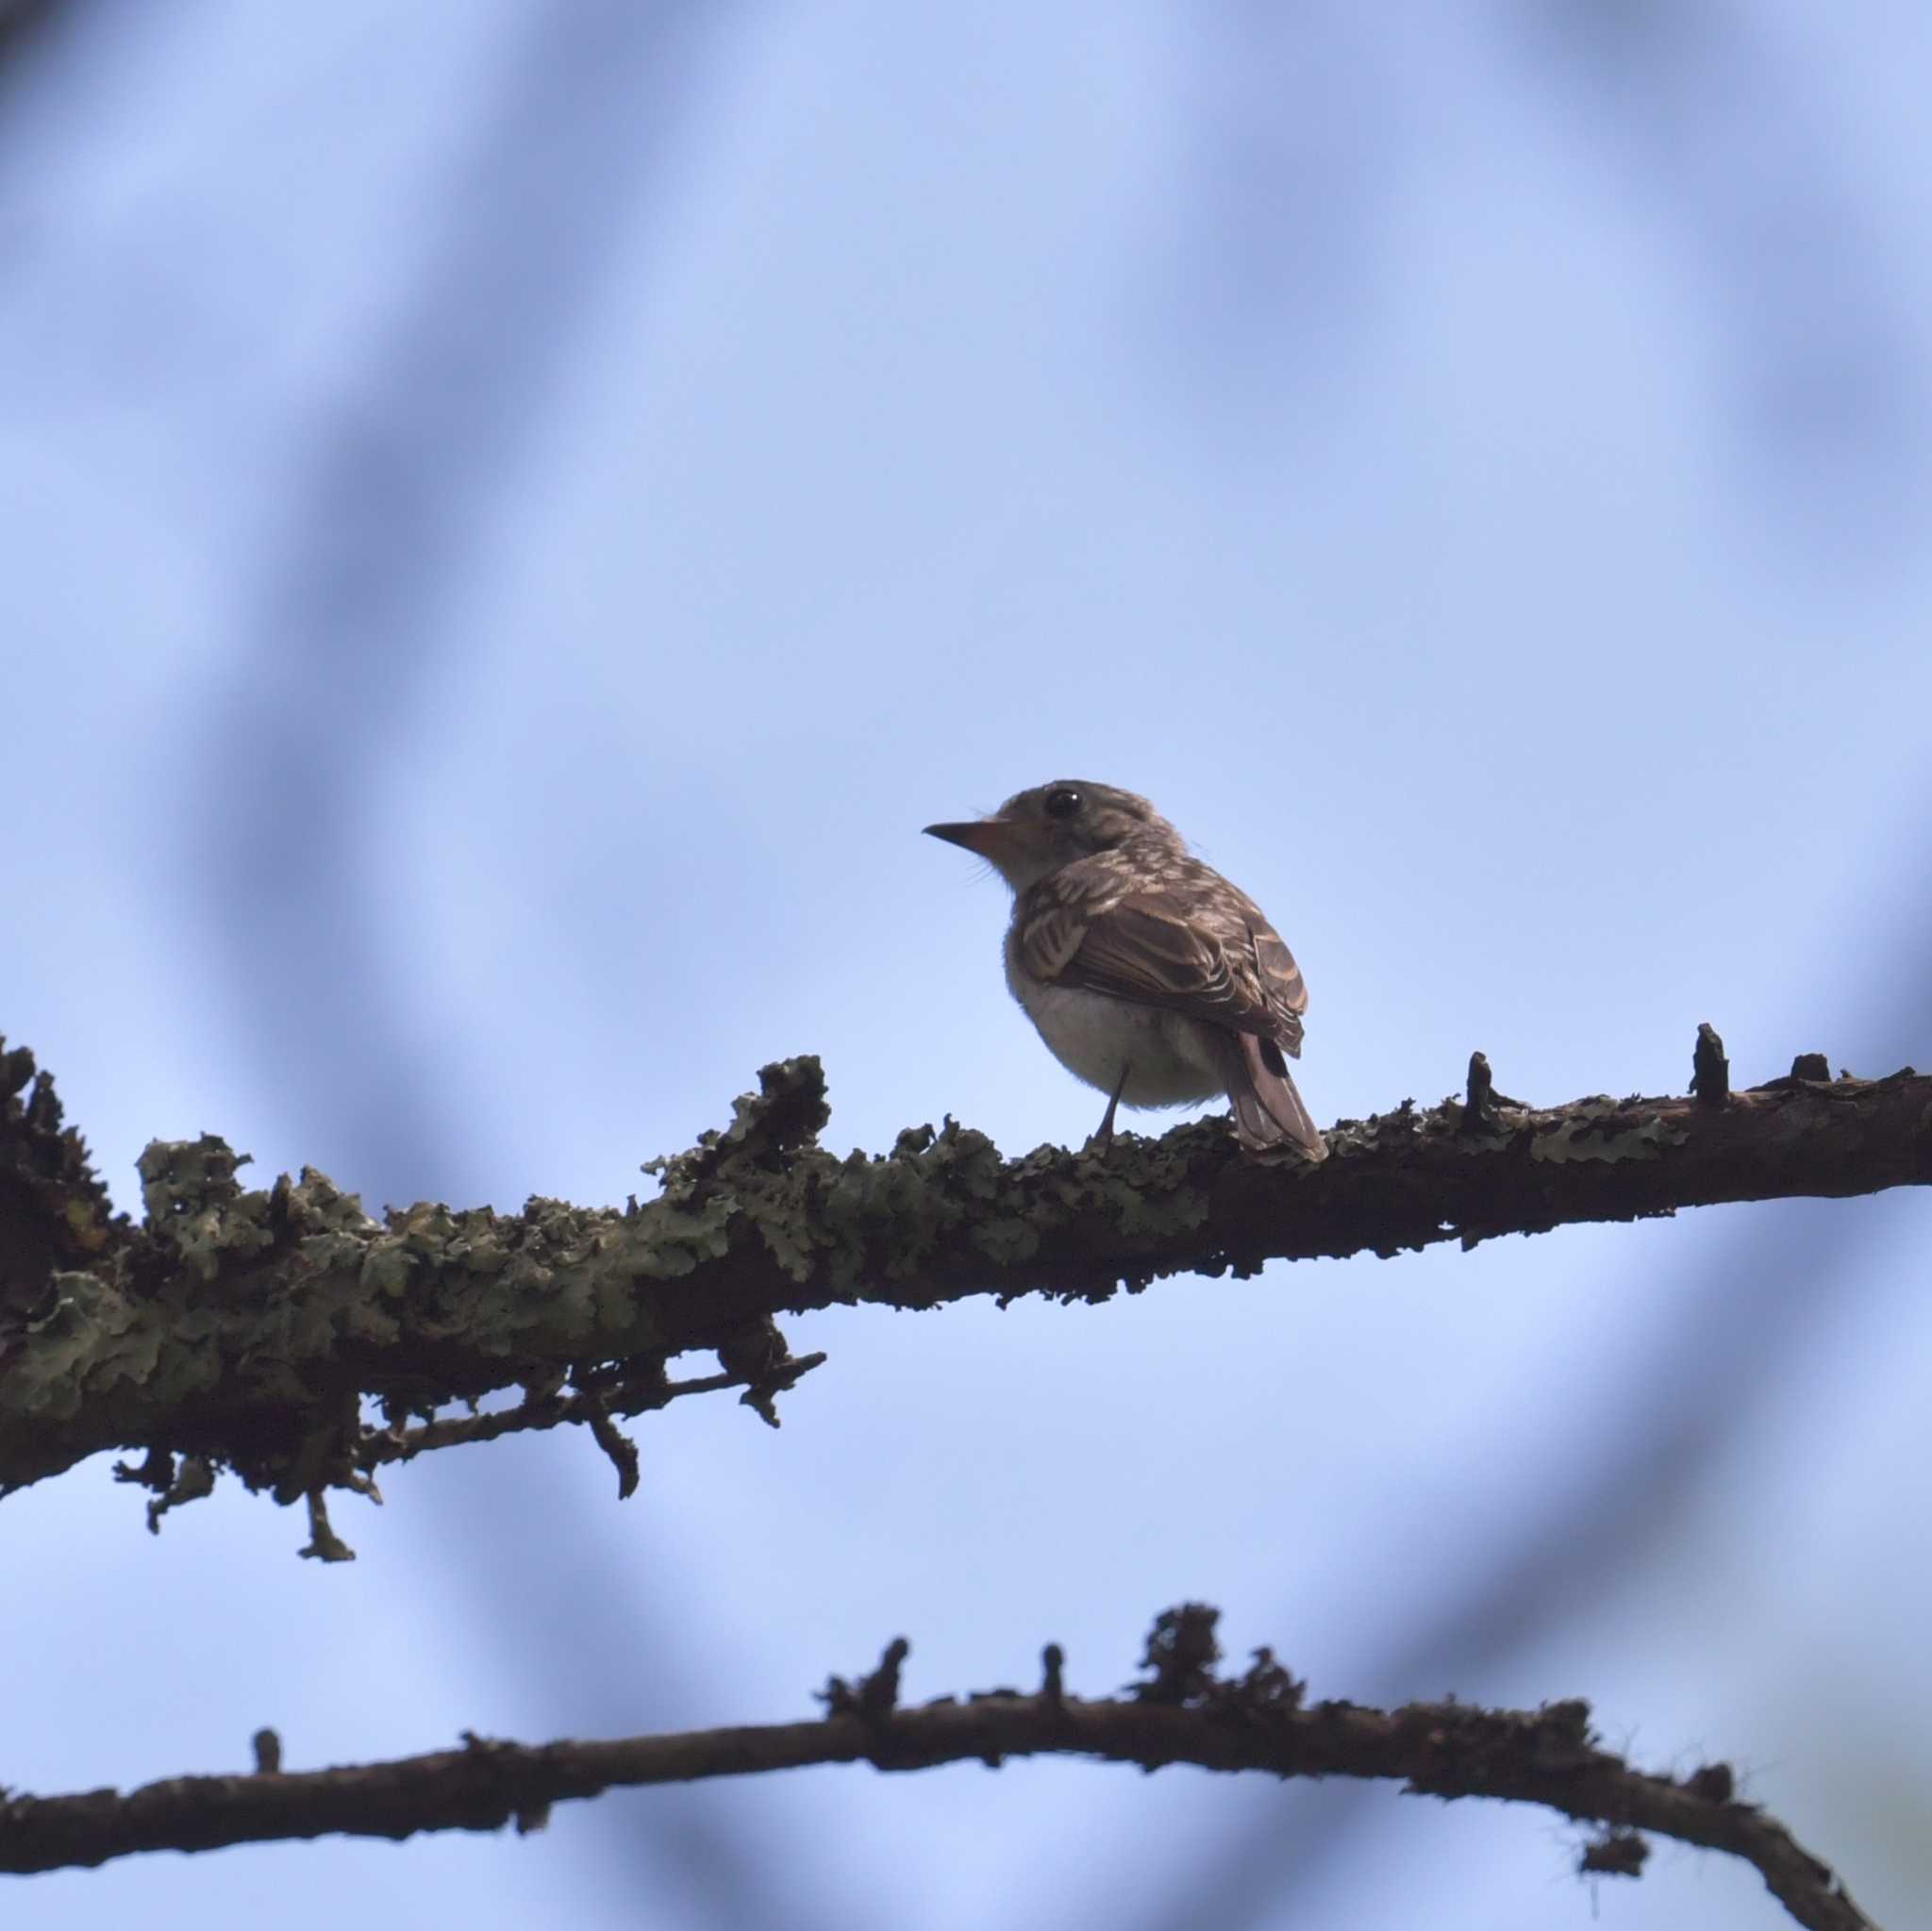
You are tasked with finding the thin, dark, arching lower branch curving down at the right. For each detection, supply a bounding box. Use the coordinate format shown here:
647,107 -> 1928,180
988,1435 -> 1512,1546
0,1603 -> 1873,1931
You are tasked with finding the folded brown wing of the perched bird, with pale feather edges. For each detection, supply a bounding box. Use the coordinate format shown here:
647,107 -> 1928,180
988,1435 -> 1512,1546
1020,880 -> 1307,1057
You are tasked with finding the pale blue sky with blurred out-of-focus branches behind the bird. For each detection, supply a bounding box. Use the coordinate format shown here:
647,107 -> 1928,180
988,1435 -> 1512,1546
0,0 -> 1932,1931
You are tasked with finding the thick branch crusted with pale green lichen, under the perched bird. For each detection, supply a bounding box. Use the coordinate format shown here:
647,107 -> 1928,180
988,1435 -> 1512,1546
0,1033 -> 1932,1529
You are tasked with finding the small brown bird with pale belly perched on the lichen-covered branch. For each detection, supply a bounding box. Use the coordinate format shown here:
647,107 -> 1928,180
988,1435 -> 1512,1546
925,778 -> 1327,1160
